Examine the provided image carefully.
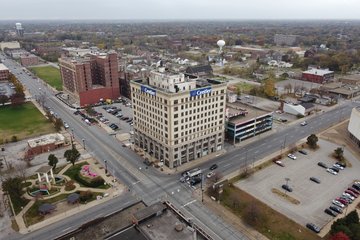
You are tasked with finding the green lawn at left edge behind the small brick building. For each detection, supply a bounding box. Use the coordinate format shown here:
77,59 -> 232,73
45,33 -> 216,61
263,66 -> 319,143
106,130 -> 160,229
0,102 -> 55,142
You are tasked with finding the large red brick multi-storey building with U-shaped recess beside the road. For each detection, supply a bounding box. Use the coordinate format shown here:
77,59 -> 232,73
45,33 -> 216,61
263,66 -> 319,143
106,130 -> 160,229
59,52 -> 120,106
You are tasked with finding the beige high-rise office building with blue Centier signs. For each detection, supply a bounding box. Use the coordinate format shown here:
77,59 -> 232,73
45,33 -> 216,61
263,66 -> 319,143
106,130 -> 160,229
131,68 -> 226,168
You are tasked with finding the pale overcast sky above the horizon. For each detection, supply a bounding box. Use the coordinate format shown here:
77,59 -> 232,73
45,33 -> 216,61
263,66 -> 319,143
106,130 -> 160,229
0,0 -> 360,20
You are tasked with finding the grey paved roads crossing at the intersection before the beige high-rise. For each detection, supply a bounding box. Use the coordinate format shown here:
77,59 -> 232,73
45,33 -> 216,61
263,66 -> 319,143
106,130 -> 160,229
4,53 -> 359,240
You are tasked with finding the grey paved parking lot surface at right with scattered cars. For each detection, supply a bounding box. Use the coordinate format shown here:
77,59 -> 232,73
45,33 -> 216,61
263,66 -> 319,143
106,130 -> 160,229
236,139 -> 360,227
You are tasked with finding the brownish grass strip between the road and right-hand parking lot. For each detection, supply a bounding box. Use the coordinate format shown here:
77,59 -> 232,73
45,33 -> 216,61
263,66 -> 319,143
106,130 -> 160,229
221,186 -> 321,240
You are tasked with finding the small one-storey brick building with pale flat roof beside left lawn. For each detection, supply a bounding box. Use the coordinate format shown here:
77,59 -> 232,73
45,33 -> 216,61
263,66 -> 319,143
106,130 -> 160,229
26,133 -> 66,156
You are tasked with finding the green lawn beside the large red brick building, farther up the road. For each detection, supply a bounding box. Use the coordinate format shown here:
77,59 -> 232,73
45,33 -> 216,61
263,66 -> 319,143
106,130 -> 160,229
30,66 -> 62,91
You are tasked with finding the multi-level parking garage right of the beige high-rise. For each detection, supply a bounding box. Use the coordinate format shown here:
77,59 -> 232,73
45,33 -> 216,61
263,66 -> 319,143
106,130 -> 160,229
225,102 -> 273,144
